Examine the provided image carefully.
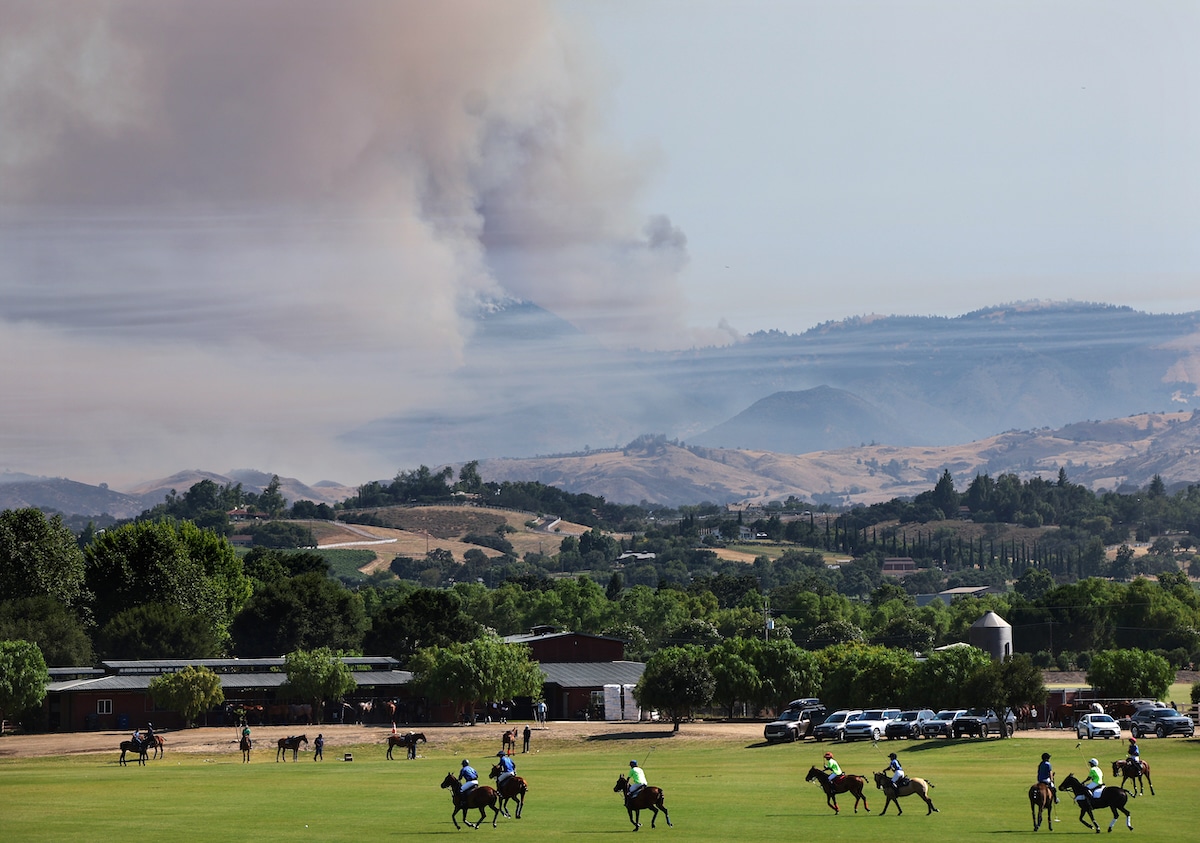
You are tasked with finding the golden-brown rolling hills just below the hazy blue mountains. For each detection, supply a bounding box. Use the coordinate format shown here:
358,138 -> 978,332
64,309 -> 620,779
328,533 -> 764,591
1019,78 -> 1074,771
480,412 -> 1200,506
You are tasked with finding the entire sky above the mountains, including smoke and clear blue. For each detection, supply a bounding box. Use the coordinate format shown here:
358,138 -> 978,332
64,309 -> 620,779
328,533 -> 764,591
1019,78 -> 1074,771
0,0 -> 1200,488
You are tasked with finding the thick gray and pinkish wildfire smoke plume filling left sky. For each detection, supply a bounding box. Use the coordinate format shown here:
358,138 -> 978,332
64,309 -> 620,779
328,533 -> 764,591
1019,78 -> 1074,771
0,0 -> 686,480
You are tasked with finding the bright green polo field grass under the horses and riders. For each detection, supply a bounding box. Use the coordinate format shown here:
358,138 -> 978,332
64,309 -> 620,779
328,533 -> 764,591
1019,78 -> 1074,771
0,727 -> 1200,843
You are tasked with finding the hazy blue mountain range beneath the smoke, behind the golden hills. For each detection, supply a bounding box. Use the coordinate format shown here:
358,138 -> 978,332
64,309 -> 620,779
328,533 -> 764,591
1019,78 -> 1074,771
344,301 -> 1200,467
